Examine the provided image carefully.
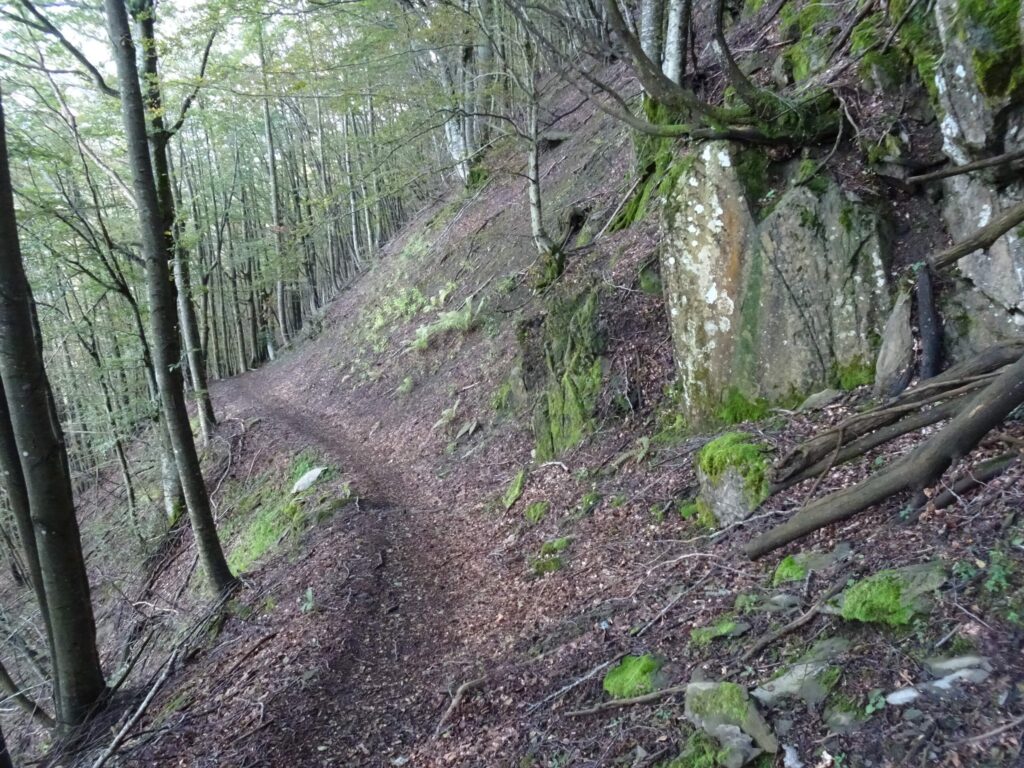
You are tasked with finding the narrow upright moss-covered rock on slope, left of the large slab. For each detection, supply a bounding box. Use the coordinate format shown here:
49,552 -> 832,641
534,289 -> 603,461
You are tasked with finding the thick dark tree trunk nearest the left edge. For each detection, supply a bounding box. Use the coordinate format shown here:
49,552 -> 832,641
0,88 -> 105,726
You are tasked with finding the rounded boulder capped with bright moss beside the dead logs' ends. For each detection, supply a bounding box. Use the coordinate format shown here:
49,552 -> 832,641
697,432 -> 770,525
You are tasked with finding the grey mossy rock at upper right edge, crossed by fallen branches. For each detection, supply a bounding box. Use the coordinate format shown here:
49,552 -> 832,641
934,0 -> 1024,352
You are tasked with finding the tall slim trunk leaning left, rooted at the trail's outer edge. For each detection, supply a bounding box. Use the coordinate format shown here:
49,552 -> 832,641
104,0 -> 236,594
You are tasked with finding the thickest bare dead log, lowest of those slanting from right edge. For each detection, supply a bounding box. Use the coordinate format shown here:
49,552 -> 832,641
743,355 -> 1024,558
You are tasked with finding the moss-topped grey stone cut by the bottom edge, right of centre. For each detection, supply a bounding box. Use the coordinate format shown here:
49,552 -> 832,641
685,682 -> 778,768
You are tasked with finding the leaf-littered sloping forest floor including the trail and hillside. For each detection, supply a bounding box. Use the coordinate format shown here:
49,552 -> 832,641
61,69 -> 1024,768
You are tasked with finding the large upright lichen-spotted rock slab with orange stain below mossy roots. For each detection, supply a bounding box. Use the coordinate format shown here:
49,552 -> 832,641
662,142 -> 890,426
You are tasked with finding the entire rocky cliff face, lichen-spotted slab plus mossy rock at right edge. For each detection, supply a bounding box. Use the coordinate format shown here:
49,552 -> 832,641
660,0 -> 1024,426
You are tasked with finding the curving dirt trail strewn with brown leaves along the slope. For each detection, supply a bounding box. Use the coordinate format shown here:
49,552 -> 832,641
147,344 -> 509,766
